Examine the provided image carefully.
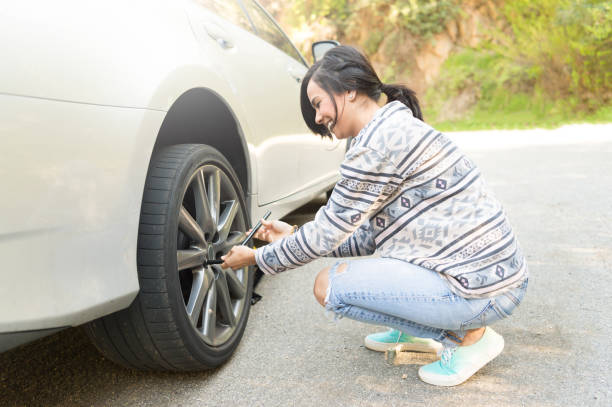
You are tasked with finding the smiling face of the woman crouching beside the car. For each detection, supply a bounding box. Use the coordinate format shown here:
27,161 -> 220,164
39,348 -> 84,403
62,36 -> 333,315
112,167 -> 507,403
306,80 -> 351,139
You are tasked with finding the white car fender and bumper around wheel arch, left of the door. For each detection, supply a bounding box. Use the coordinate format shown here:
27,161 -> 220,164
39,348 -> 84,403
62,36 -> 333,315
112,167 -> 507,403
0,0 -> 258,332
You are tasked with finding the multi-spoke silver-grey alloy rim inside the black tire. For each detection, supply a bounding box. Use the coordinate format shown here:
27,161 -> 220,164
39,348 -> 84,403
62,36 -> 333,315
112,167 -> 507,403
176,164 -> 249,346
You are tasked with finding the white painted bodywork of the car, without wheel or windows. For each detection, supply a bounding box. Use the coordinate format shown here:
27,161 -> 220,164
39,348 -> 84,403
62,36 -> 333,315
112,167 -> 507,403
0,0 -> 344,333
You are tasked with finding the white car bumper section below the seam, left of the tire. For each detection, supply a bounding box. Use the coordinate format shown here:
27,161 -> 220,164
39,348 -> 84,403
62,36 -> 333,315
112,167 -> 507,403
0,95 -> 164,332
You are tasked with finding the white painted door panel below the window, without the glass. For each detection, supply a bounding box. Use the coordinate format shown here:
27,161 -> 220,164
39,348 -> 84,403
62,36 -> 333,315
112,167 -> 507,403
184,3 -> 342,205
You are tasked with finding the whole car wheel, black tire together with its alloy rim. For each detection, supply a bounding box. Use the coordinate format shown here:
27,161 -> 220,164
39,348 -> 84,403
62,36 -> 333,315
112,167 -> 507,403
85,144 -> 253,371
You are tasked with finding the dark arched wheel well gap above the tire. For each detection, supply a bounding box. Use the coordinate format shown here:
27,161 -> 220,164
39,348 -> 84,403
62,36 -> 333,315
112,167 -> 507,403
153,88 -> 250,196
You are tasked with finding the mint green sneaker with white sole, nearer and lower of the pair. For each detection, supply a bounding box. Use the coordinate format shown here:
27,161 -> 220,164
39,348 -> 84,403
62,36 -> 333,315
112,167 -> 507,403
419,327 -> 504,386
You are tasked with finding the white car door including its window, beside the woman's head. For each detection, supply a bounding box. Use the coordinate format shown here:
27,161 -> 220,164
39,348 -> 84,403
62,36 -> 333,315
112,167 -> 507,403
190,0 -> 342,205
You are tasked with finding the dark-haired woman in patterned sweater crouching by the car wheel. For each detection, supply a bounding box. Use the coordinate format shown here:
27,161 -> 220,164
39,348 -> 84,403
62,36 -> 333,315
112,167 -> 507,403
223,46 -> 528,386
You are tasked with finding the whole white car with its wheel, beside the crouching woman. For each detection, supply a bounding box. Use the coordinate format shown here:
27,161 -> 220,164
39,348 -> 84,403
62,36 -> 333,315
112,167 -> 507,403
0,0 -> 345,371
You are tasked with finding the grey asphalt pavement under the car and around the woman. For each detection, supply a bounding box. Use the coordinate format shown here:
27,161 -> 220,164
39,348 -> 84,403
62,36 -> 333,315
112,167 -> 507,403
0,125 -> 612,406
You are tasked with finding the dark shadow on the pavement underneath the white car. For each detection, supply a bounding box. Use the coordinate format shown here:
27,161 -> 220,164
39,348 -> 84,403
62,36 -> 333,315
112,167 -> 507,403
0,197 -> 325,406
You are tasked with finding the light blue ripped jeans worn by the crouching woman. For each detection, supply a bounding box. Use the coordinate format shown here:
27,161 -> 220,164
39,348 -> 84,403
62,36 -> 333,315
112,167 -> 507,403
325,258 -> 527,347
